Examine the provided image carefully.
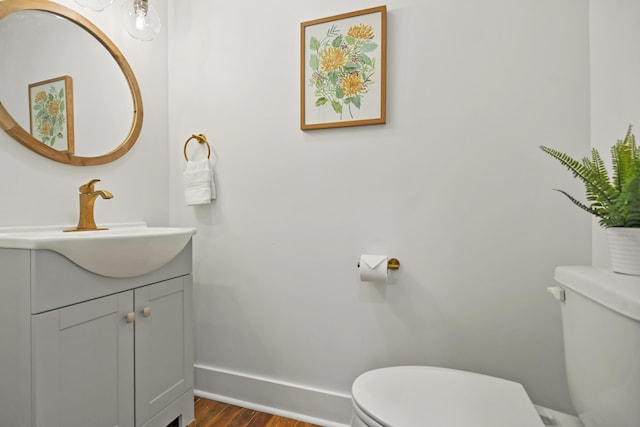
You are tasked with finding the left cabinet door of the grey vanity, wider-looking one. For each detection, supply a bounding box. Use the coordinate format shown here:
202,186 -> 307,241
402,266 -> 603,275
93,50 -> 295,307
31,291 -> 134,427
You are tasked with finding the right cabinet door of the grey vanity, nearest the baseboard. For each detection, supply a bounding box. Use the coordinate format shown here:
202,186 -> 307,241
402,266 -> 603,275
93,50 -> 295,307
135,276 -> 193,426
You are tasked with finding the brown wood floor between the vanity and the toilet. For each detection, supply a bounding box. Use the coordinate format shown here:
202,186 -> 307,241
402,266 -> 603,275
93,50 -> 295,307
188,397 -> 320,427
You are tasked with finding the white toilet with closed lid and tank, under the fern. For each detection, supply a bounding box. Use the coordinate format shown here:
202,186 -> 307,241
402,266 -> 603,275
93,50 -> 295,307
351,266 -> 640,427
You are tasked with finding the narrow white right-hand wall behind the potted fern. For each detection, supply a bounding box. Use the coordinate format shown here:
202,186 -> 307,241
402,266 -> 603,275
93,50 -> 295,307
585,0 -> 640,265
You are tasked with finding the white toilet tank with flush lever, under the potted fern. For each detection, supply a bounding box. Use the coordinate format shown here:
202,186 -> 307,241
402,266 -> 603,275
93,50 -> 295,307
555,266 -> 640,427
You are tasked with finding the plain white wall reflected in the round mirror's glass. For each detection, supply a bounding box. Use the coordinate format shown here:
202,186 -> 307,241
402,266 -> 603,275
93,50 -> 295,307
0,10 -> 133,157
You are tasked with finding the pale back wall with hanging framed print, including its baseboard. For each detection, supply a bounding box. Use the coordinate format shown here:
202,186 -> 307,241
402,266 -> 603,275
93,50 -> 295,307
169,0 -> 591,422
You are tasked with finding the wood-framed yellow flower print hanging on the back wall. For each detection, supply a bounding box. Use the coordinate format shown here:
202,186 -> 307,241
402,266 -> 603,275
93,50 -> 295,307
300,6 -> 387,130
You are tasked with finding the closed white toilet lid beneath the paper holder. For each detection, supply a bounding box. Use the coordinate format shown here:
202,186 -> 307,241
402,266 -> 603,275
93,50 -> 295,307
351,366 -> 544,427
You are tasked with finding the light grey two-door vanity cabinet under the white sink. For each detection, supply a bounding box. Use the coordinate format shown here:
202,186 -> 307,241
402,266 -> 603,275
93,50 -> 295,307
0,243 -> 194,427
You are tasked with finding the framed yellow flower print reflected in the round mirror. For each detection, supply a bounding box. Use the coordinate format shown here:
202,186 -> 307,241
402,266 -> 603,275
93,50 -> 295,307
29,76 -> 74,153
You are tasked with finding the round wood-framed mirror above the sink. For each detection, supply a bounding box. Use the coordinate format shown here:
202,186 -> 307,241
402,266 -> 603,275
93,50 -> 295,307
0,0 -> 143,165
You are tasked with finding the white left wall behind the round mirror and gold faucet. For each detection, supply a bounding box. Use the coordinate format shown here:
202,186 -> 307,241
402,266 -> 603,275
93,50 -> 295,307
0,0 -> 169,226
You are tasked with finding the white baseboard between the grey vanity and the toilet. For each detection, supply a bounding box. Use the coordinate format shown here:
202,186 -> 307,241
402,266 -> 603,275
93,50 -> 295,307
195,364 -> 351,427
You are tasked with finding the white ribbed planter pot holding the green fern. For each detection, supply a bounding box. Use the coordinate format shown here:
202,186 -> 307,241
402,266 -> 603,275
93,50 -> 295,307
607,227 -> 640,276
